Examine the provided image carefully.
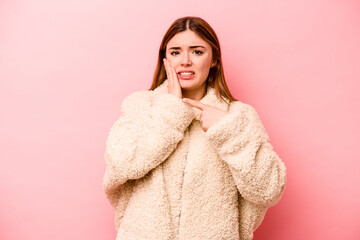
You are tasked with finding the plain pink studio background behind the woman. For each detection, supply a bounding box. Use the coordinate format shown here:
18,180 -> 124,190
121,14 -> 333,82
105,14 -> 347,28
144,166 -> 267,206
0,0 -> 360,240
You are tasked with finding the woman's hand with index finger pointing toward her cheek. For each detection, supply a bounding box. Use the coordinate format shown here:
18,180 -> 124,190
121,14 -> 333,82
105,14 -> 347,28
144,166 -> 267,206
183,98 -> 229,132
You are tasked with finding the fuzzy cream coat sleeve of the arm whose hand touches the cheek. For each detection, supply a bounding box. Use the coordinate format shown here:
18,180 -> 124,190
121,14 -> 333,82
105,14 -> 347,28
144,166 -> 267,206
103,90 -> 194,207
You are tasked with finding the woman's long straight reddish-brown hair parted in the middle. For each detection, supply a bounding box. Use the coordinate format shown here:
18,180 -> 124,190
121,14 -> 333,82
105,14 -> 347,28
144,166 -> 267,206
149,16 -> 237,102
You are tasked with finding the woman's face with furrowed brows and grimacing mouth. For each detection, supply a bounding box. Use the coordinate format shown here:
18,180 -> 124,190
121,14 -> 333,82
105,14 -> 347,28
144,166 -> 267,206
166,30 -> 215,92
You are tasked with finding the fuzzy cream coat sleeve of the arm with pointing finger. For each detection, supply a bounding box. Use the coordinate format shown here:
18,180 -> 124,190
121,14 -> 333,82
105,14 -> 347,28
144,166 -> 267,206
205,101 -> 286,208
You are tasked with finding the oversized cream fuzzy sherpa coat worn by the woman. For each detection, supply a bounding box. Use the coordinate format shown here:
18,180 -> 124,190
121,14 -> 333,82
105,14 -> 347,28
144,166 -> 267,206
103,80 -> 286,240
